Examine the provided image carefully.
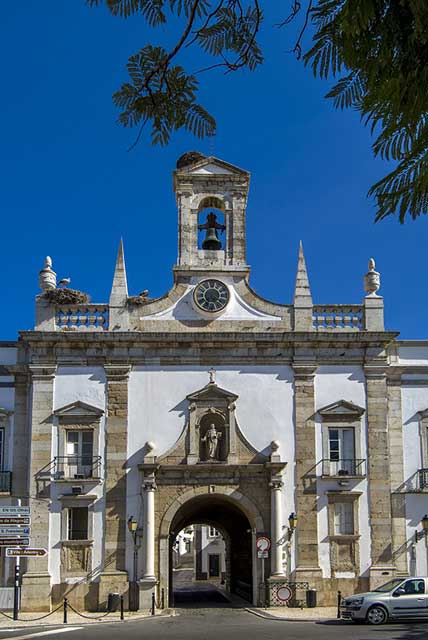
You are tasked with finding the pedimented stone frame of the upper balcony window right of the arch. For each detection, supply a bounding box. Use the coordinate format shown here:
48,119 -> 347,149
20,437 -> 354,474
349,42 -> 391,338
317,400 -> 367,479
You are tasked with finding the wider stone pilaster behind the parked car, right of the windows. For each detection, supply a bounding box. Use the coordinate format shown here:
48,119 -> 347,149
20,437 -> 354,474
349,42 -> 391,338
364,364 -> 394,589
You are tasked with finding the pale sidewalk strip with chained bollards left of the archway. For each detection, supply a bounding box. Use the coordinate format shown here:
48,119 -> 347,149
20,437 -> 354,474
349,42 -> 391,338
0,609 -> 171,630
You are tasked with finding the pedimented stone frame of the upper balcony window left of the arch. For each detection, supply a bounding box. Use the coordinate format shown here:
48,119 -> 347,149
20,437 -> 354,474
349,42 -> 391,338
53,401 -> 104,483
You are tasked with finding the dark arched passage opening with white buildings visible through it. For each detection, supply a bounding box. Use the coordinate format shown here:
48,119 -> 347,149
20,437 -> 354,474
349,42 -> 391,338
169,494 -> 253,606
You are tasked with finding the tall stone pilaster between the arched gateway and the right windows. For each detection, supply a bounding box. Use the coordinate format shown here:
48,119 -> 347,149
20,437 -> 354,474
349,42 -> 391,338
293,363 -> 321,581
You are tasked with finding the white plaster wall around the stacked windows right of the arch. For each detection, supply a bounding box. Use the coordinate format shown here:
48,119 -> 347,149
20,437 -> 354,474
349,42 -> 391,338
315,366 -> 370,578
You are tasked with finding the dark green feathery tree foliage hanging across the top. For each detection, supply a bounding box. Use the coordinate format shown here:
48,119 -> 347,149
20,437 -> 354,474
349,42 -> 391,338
87,0 -> 428,222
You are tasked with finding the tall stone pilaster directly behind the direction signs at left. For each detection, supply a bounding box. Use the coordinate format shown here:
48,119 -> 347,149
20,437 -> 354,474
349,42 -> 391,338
21,363 -> 56,611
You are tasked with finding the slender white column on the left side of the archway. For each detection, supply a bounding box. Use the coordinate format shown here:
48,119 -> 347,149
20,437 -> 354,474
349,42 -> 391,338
140,476 -> 157,609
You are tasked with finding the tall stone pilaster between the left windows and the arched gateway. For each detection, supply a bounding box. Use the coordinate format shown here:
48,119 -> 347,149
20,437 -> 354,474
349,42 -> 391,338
99,365 -> 130,607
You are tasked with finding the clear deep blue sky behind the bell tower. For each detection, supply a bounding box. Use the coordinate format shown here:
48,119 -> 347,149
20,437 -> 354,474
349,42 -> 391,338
0,0 -> 428,340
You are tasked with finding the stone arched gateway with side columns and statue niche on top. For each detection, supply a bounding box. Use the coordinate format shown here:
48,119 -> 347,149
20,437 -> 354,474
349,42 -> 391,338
139,374 -> 285,607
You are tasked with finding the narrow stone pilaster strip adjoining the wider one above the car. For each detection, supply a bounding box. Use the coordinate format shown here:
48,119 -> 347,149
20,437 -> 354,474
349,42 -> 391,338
387,373 -> 408,575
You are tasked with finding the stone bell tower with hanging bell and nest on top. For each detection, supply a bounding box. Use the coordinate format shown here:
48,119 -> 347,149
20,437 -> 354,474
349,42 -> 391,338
174,151 -> 250,279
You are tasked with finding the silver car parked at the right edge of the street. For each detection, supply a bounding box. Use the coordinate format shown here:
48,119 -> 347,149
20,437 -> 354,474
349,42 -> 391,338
340,577 -> 428,624
